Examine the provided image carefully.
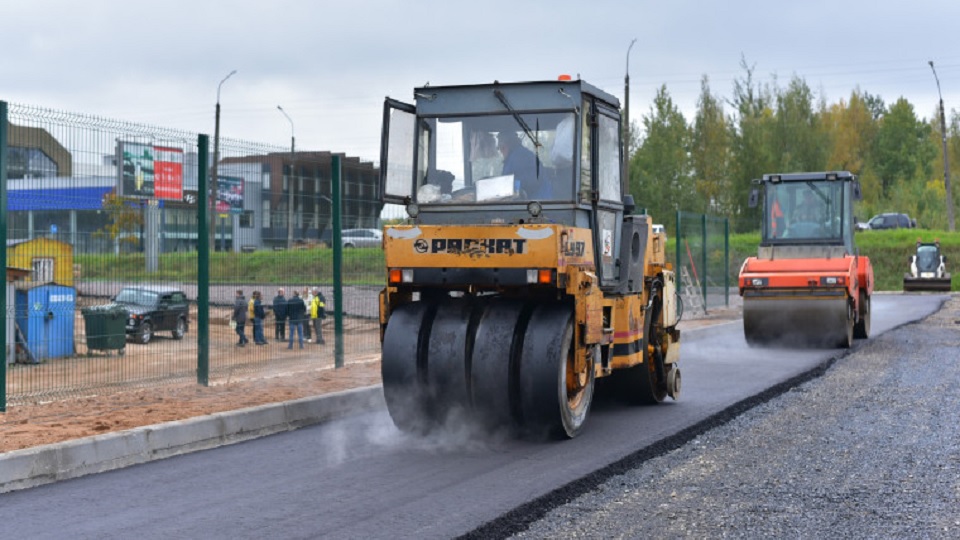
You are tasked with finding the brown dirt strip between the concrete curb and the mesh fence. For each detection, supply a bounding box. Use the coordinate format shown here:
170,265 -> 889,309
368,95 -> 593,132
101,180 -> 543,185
0,308 -> 740,453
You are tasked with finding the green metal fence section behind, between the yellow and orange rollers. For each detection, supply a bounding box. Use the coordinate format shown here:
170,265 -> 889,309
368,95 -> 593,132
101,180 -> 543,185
674,212 -> 736,315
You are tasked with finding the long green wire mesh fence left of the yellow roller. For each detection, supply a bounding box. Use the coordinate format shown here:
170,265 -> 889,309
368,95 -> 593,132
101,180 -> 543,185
0,102 -> 384,410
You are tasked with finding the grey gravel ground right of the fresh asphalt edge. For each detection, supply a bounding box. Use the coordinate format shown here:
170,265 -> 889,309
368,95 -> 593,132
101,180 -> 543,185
516,296 -> 960,538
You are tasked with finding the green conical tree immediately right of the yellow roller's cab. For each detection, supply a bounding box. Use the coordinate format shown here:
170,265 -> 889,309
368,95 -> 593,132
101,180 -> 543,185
630,86 -> 688,227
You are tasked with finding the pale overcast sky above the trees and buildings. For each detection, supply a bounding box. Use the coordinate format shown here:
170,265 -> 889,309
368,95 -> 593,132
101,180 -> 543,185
0,0 -> 960,161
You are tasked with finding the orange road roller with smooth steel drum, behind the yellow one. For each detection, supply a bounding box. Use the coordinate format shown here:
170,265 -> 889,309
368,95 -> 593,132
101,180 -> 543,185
739,171 -> 874,348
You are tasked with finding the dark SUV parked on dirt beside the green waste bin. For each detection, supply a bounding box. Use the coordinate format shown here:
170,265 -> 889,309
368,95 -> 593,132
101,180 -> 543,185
113,286 -> 190,345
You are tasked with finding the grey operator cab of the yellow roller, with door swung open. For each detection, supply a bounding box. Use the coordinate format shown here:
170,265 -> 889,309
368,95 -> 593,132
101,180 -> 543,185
381,80 -> 623,227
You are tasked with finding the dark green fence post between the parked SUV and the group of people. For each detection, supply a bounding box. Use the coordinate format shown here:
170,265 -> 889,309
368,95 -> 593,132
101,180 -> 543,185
197,134 -> 209,386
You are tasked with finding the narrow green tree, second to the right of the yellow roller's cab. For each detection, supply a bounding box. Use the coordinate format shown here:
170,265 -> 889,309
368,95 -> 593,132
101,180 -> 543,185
690,75 -> 737,215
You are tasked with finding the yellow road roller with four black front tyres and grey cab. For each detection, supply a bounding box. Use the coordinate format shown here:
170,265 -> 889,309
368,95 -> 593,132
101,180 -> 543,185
380,77 -> 680,438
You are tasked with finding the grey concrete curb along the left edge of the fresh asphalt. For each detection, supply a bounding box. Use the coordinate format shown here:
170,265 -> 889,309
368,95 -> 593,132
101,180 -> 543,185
0,385 -> 385,493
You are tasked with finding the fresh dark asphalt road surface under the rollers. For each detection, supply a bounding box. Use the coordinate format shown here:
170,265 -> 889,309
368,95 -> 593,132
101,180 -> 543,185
0,295 -> 944,539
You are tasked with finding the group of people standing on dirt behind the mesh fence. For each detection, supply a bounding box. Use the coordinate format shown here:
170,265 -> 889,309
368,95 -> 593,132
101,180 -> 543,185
230,287 -> 327,349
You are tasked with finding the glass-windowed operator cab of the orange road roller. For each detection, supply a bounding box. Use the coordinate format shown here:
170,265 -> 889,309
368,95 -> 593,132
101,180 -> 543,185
751,171 -> 860,254
